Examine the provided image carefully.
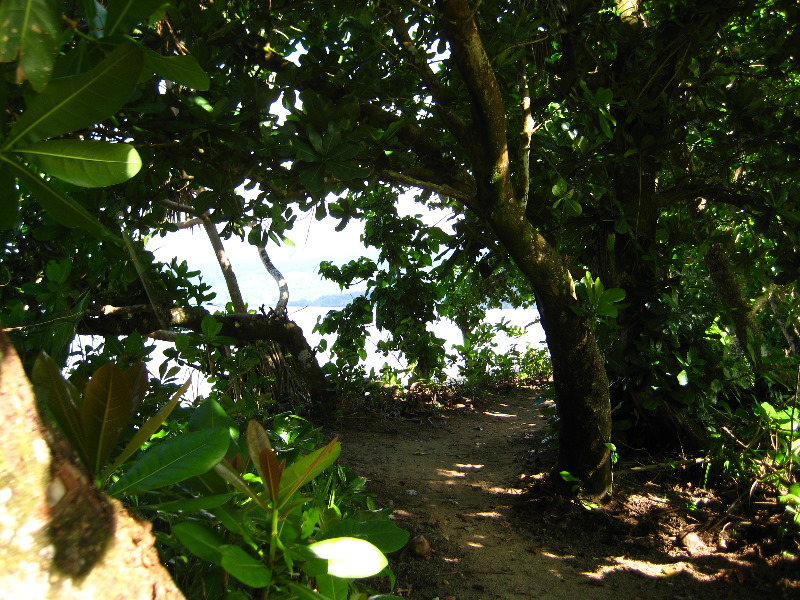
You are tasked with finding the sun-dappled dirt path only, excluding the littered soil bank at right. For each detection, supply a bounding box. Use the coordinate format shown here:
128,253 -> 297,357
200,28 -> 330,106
330,390 -> 800,600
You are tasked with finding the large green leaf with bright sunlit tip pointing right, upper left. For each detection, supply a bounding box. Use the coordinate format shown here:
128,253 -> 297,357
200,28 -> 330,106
15,140 -> 142,187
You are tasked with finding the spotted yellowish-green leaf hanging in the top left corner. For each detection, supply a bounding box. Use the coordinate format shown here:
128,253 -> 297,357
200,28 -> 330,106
0,0 -> 61,90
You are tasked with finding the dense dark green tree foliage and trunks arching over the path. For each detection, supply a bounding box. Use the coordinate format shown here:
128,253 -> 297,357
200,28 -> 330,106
0,0 -> 800,592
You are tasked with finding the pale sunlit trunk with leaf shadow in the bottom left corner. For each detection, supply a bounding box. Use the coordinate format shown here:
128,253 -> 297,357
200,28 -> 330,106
0,332 -> 183,600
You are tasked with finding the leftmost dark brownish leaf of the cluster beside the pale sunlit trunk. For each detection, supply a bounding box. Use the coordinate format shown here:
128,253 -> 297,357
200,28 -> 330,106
31,351 -> 89,465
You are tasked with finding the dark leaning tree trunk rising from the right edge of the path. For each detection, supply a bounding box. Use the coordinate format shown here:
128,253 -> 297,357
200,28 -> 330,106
439,0 -> 611,497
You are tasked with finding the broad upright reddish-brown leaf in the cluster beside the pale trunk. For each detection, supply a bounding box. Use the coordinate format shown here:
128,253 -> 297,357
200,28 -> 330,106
81,363 -> 147,475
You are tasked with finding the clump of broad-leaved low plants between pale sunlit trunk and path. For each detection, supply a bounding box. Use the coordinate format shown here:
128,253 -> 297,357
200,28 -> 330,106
33,355 -> 408,600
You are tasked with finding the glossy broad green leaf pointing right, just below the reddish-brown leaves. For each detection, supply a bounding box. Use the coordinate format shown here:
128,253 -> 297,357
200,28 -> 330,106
108,428 -> 230,495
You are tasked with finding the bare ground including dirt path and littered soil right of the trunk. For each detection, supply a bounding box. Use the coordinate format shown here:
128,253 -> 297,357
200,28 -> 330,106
336,388 -> 800,600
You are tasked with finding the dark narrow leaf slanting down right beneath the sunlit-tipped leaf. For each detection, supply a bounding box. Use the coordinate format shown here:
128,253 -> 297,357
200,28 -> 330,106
0,153 -> 120,244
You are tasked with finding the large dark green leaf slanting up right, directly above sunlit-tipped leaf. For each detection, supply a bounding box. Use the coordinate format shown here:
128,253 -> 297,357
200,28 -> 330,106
5,42 -> 142,149
